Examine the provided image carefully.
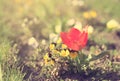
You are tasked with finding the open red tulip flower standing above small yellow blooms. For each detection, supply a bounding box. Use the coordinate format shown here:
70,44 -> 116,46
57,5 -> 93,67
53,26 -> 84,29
60,27 -> 88,51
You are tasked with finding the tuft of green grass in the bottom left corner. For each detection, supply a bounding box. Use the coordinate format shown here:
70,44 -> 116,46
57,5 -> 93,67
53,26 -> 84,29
0,40 -> 24,81
